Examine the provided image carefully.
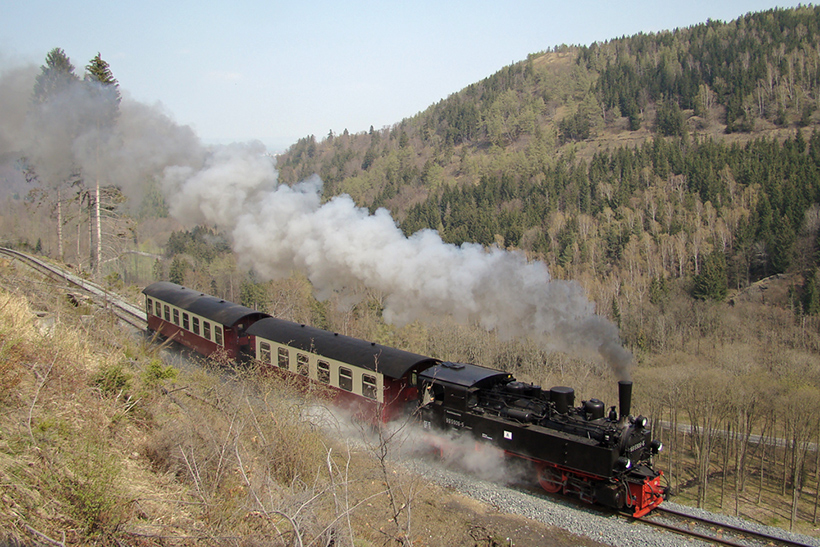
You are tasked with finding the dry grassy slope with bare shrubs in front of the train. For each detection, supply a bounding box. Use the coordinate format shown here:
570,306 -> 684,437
0,271 -> 604,547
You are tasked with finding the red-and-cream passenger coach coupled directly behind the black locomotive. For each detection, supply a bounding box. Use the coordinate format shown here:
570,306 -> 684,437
248,317 -> 438,422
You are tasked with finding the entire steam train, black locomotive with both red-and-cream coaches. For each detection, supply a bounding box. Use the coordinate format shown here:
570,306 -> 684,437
143,282 -> 667,517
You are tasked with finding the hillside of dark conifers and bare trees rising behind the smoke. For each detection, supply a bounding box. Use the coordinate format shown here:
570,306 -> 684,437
279,7 -> 820,322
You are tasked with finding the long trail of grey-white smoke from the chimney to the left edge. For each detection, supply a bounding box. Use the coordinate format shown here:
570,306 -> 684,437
0,58 -> 631,378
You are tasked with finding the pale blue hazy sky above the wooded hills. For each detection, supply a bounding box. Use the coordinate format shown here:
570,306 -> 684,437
0,0 -> 799,152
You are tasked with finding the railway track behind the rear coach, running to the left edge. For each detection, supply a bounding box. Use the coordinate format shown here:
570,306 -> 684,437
0,247 -> 147,330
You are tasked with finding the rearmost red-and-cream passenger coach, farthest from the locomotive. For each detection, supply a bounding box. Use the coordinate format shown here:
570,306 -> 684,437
142,281 -> 270,359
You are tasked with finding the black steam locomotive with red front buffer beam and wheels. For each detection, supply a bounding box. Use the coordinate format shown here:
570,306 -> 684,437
418,363 -> 667,517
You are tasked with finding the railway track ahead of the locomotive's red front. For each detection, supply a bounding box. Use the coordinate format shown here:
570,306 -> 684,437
638,505 -> 813,547
